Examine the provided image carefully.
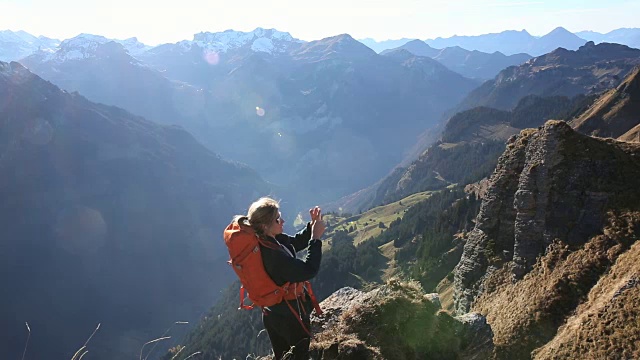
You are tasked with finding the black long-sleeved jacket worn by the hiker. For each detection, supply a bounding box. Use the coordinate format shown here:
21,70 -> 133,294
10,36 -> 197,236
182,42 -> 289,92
261,223 -> 322,312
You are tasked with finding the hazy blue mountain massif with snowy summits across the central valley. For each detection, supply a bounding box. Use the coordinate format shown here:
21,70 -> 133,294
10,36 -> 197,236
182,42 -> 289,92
21,29 -> 479,206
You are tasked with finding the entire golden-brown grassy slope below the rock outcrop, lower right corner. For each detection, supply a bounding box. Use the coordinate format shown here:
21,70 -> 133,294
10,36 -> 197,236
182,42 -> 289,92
474,212 -> 640,359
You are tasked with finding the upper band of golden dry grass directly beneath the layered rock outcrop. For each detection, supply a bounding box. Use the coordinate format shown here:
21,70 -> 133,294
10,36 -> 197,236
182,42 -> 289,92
474,212 -> 640,359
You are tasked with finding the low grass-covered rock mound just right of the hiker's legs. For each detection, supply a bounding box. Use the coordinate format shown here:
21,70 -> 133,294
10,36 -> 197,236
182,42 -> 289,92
311,280 -> 493,359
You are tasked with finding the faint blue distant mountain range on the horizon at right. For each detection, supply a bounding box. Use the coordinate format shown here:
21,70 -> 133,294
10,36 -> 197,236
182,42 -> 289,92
360,27 -> 640,56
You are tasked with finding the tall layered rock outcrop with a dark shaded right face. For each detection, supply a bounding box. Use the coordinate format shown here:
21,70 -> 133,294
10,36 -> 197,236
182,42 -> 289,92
455,121 -> 640,313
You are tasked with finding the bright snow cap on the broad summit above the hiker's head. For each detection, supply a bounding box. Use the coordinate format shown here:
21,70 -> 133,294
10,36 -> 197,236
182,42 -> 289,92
188,28 -> 302,54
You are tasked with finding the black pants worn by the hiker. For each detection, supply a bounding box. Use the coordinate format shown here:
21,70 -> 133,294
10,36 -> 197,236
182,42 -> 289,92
262,301 -> 311,360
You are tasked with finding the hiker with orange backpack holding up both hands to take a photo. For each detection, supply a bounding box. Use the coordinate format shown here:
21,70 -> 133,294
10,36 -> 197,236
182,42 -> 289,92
225,197 -> 325,360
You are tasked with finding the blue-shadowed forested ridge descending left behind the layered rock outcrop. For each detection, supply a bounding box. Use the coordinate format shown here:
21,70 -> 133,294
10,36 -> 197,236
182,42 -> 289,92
334,95 -> 594,211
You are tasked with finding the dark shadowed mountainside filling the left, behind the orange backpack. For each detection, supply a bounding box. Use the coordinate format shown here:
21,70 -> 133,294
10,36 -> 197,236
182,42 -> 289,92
0,62 -> 271,359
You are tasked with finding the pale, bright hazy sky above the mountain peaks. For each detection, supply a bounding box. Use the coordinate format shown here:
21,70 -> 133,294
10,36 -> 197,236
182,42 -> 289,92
0,0 -> 640,45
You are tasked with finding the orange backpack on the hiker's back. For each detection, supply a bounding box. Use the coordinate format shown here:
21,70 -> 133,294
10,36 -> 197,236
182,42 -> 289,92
224,221 -> 322,315
